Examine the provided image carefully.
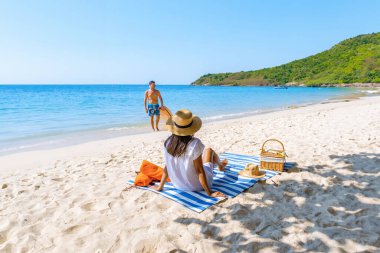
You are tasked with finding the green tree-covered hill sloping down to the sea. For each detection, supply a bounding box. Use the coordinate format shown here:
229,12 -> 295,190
193,33 -> 380,86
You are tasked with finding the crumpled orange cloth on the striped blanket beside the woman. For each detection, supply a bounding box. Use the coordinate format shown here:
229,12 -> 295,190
135,160 -> 170,186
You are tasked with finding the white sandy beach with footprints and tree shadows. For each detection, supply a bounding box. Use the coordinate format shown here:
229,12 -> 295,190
0,97 -> 380,252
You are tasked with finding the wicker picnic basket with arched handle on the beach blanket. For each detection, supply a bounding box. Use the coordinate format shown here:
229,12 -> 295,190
260,139 -> 286,172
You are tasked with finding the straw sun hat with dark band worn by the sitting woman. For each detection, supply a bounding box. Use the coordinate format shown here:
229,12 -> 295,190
166,109 -> 202,136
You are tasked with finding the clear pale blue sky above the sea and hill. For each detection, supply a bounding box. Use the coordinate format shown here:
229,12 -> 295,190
0,0 -> 380,84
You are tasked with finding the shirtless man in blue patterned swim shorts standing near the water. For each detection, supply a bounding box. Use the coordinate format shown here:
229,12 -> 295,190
144,81 -> 164,131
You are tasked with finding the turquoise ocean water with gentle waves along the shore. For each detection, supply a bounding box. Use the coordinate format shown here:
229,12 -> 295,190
0,85 -> 356,155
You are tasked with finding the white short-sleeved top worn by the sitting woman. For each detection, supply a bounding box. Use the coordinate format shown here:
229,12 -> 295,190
164,137 -> 213,191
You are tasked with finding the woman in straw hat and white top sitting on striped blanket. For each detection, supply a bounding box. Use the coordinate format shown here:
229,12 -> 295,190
153,109 -> 227,197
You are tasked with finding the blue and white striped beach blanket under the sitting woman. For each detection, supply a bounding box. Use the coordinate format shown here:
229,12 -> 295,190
128,153 -> 294,213
